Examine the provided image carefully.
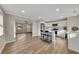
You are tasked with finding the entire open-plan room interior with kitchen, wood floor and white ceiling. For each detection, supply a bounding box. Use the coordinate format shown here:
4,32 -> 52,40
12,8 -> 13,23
0,4 -> 79,54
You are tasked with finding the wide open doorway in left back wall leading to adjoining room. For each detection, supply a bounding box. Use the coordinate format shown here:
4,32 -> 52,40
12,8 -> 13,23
16,20 -> 32,40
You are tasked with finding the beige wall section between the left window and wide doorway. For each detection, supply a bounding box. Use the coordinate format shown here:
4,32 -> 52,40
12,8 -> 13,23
4,14 -> 16,43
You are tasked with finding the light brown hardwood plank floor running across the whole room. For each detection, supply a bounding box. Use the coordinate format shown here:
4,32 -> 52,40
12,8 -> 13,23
2,33 -> 77,54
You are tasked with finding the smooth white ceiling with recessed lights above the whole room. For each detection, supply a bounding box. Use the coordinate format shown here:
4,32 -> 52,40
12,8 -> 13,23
2,4 -> 79,21
